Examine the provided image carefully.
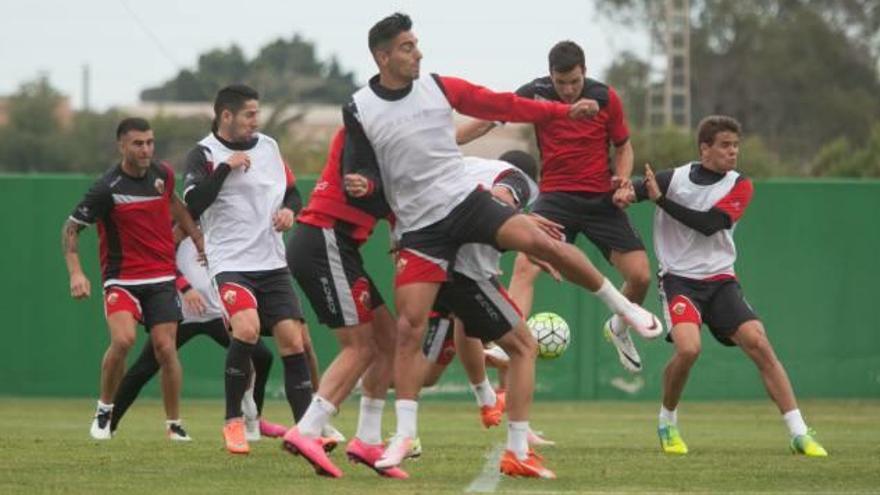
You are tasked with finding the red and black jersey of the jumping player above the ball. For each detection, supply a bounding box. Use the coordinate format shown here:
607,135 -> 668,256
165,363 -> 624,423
516,76 -> 629,193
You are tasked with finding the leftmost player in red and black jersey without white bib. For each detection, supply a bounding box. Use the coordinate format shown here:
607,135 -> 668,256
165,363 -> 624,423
61,118 -> 202,440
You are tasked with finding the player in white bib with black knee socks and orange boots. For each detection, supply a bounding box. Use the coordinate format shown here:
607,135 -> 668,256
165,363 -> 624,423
184,85 -> 312,454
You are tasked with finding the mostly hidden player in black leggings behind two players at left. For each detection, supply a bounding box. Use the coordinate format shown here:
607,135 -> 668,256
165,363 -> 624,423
110,234 -> 286,441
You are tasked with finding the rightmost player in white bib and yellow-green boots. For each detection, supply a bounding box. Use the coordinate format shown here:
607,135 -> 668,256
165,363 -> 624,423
635,115 -> 828,457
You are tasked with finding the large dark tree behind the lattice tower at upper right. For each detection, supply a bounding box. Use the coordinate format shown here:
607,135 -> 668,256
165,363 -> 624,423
599,0 -> 880,172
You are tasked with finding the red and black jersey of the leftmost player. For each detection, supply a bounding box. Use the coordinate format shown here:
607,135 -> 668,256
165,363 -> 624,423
70,163 -> 176,285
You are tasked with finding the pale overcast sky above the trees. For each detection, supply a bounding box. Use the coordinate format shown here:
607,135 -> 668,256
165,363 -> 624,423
0,0 -> 647,109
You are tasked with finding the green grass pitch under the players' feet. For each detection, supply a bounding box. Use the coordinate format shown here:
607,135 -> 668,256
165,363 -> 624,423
0,398 -> 880,494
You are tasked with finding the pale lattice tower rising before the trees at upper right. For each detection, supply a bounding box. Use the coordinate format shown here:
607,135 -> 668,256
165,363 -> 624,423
646,0 -> 691,129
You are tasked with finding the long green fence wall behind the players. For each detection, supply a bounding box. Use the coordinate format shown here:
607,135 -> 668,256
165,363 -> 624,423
0,175 -> 880,400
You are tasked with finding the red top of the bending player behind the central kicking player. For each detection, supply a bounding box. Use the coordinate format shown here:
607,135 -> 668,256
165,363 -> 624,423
298,127 -> 391,241
